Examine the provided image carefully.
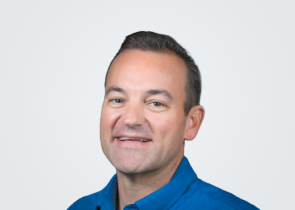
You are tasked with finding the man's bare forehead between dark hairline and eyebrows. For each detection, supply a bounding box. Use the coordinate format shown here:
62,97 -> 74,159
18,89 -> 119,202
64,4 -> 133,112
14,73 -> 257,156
106,49 -> 187,94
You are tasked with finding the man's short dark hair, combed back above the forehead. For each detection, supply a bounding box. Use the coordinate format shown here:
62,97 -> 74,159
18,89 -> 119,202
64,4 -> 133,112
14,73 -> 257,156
105,31 -> 202,116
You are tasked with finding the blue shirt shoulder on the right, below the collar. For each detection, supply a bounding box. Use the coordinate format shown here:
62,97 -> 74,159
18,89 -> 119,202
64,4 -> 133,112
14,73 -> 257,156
180,179 -> 258,210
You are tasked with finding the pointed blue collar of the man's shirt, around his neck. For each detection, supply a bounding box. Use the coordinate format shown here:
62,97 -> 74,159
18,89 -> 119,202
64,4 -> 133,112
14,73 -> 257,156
98,157 -> 198,210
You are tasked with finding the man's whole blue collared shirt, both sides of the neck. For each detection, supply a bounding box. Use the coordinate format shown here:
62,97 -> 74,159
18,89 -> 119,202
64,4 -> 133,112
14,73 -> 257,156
68,157 -> 258,210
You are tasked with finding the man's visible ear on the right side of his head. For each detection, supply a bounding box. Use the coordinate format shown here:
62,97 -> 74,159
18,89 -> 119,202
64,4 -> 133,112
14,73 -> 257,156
184,105 -> 205,140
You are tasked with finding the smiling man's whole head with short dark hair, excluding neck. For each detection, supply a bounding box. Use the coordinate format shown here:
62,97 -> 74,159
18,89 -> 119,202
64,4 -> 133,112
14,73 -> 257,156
100,32 -> 204,174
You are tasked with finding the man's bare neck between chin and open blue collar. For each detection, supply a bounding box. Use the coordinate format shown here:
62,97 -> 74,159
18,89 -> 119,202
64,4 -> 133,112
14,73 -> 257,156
116,154 -> 183,210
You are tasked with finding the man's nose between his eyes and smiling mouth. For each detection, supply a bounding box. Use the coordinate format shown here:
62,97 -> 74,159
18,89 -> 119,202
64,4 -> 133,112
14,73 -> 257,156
121,104 -> 146,127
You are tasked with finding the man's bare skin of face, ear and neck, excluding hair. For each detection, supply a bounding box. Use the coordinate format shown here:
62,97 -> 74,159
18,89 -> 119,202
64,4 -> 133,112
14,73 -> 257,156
100,49 -> 204,209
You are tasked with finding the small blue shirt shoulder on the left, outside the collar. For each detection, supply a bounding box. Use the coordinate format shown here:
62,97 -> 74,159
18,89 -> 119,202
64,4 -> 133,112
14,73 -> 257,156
67,191 -> 104,210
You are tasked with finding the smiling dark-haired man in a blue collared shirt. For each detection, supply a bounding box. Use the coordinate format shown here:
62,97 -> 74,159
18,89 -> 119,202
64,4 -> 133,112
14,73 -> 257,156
69,32 -> 257,210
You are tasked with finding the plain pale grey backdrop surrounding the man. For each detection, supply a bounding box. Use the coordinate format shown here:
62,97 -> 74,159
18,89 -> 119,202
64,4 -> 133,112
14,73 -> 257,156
0,0 -> 295,210
